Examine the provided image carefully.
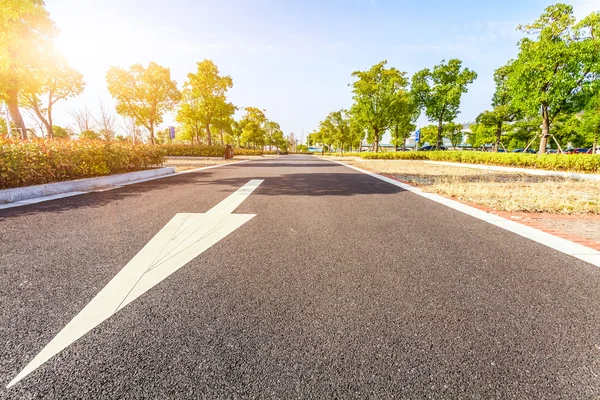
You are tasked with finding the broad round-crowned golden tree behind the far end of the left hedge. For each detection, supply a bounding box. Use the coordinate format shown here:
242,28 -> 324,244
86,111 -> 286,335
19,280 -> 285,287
106,62 -> 181,144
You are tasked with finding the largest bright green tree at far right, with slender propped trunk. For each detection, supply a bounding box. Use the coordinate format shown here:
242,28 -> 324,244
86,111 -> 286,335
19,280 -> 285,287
508,3 -> 600,153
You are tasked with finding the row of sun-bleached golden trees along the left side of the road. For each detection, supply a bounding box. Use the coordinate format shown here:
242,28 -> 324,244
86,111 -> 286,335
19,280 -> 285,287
0,0 -> 287,148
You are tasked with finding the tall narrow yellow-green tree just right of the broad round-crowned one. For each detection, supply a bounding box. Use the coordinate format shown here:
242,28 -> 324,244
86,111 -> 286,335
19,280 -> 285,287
184,60 -> 235,145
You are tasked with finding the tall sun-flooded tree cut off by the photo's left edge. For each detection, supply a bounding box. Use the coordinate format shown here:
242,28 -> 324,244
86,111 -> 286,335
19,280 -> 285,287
0,0 -> 56,139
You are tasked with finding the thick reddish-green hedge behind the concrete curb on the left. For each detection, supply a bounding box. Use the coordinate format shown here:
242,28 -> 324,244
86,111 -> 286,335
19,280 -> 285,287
0,139 -> 164,189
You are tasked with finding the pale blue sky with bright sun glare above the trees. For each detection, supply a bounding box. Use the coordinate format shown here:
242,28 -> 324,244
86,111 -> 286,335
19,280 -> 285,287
41,0 -> 600,141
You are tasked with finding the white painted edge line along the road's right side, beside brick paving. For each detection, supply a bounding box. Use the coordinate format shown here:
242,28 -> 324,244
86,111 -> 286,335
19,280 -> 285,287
329,160 -> 600,267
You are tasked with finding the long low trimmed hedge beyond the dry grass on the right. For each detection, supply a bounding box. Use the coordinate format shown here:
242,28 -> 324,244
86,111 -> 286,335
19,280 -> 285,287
356,151 -> 600,173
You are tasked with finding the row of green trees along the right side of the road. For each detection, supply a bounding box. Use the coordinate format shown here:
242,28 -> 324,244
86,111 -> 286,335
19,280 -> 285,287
309,3 -> 600,153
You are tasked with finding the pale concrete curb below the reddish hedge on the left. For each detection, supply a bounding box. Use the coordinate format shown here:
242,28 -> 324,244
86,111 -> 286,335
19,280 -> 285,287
0,167 -> 175,204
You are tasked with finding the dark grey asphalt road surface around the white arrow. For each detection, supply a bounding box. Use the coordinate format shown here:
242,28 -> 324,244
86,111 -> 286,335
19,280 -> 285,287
0,156 -> 600,400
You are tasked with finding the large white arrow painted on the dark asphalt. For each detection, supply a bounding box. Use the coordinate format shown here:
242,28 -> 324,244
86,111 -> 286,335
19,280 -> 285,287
7,179 -> 263,388
